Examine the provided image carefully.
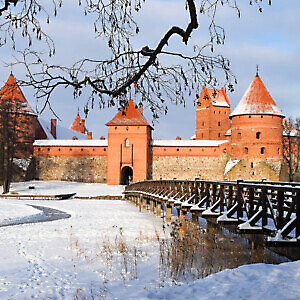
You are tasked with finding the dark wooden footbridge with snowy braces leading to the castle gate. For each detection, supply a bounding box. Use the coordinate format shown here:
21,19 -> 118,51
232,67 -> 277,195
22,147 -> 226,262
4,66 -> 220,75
125,180 -> 300,258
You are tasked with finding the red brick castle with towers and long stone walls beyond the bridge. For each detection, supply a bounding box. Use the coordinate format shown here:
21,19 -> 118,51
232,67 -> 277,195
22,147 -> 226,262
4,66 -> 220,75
2,75 -> 287,184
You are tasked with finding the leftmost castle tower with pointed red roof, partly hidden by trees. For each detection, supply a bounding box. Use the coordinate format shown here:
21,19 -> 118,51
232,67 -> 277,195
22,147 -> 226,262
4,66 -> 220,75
0,74 -> 36,157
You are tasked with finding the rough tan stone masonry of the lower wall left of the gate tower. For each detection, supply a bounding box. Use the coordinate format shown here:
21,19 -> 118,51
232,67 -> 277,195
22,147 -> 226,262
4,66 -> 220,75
36,156 -> 107,183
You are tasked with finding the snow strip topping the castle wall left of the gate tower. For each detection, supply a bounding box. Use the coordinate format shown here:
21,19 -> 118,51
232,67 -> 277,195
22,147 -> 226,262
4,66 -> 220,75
33,140 -> 108,147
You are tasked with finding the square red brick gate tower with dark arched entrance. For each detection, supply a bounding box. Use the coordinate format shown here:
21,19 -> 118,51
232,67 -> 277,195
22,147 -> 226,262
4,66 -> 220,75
106,100 -> 152,184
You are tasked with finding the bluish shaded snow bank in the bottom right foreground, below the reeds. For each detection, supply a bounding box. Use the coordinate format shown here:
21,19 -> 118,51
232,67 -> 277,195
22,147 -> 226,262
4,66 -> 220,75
141,261 -> 300,300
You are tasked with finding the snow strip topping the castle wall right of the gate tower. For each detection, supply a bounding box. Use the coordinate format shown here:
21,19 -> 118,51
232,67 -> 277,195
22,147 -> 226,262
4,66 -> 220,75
152,140 -> 228,147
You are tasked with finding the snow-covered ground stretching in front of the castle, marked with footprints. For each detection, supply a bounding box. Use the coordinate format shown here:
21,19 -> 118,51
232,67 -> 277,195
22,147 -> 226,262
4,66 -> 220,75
0,182 -> 300,299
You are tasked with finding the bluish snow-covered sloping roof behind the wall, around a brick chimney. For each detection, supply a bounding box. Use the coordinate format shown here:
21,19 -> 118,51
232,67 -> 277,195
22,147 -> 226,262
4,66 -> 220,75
38,118 -> 87,140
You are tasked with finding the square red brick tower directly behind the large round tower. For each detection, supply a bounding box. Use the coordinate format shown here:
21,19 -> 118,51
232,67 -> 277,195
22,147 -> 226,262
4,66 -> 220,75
196,86 -> 230,140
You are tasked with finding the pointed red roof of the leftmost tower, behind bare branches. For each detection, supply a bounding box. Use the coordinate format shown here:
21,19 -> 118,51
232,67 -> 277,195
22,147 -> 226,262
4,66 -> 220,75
0,74 -> 35,115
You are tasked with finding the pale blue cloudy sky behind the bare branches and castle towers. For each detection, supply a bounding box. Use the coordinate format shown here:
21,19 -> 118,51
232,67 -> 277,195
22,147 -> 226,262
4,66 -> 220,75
0,0 -> 300,139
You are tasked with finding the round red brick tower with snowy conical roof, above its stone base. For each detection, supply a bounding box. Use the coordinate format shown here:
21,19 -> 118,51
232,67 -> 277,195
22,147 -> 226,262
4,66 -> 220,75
230,74 -> 284,158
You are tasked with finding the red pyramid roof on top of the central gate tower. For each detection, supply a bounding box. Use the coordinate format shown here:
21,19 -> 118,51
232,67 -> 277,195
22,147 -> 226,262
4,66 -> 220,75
106,100 -> 150,126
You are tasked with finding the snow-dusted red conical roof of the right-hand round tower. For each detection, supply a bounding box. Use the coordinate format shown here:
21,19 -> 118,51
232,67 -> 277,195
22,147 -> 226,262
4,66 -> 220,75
230,76 -> 284,117
